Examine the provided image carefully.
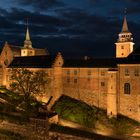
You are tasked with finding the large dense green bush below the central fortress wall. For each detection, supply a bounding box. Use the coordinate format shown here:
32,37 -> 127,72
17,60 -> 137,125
52,95 -> 97,127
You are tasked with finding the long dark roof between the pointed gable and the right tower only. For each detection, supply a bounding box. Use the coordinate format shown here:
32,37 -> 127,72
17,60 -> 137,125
63,58 -> 117,68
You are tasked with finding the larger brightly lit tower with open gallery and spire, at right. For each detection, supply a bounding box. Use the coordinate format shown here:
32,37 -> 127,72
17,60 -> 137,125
115,15 -> 134,58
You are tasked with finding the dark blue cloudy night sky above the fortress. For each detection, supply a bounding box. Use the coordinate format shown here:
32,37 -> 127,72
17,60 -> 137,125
0,0 -> 140,57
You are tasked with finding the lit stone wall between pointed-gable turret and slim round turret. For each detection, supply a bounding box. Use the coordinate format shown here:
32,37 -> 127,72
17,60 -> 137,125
63,68 -> 108,109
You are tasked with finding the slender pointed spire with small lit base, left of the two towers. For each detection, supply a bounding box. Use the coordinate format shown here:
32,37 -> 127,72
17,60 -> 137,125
21,24 -> 35,56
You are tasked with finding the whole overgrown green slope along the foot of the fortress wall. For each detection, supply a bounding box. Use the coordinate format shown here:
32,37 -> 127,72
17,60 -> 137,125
52,95 -> 139,135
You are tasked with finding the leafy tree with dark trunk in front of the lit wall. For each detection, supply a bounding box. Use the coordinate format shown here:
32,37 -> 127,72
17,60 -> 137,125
10,68 -> 50,119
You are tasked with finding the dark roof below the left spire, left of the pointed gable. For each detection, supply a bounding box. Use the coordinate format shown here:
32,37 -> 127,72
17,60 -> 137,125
9,55 -> 55,68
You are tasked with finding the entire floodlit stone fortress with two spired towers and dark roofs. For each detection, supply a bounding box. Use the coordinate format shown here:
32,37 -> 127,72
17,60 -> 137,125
0,16 -> 140,122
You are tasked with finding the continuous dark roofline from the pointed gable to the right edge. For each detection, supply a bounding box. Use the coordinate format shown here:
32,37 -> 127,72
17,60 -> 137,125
63,55 -> 140,68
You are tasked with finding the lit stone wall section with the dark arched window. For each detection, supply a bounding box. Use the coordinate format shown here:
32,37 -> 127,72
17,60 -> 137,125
118,64 -> 140,121
